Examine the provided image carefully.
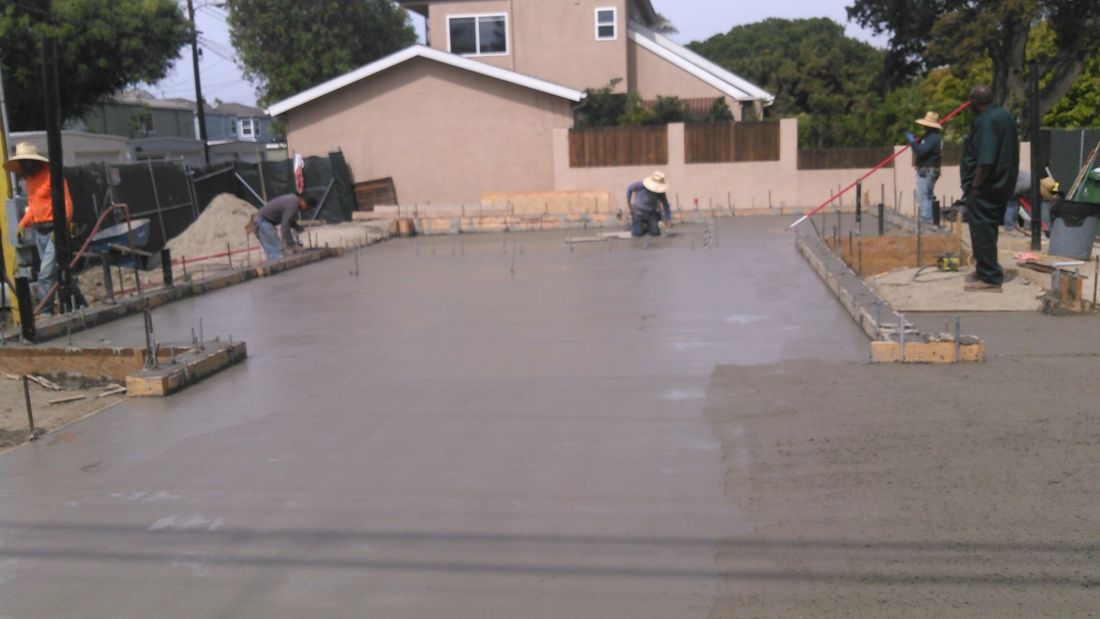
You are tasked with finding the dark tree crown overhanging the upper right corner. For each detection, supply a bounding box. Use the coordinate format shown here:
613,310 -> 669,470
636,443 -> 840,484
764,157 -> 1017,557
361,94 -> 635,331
848,0 -> 1100,114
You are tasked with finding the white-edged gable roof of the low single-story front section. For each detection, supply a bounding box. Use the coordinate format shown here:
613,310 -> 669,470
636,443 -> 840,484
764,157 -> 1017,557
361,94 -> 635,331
267,45 -> 584,117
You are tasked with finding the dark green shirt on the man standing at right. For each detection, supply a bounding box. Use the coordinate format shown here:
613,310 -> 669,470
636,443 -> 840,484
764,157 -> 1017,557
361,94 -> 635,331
959,106 -> 1020,202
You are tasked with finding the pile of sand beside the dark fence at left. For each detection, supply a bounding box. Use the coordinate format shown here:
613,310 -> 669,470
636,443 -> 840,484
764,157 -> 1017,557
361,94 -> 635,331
167,194 -> 256,262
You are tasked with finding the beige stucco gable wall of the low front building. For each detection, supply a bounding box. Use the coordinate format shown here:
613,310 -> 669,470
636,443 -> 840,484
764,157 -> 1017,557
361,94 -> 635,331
287,58 -> 572,205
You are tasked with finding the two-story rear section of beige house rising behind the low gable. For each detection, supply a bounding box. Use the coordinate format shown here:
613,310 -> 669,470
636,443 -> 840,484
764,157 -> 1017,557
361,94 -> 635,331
398,0 -> 773,120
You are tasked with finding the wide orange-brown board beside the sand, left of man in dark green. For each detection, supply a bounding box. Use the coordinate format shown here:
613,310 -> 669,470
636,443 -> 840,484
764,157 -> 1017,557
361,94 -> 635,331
825,234 -> 963,276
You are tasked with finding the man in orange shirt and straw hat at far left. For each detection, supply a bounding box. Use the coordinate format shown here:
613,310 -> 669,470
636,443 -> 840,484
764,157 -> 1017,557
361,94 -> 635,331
3,142 -> 73,316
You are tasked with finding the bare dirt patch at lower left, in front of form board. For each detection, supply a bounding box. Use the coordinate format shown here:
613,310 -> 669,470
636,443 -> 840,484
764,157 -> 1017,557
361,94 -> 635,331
0,376 -> 125,451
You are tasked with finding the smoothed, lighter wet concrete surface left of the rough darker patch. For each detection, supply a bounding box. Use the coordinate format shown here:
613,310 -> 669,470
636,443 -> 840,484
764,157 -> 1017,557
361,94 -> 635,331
0,218 -> 867,618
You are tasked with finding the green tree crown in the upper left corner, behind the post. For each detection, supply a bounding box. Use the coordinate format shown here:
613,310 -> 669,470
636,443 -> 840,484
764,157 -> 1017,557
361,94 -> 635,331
0,0 -> 190,131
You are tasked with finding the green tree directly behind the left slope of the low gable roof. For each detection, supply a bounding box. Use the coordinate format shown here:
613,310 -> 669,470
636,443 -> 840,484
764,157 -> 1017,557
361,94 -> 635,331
224,0 -> 416,104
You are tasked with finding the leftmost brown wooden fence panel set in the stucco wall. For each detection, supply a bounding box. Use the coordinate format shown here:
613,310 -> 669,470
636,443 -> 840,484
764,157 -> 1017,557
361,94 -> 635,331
569,125 -> 669,167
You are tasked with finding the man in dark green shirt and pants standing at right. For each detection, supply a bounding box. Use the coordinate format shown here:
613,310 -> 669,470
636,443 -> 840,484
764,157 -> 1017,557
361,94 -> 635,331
959,86 -> 1020,292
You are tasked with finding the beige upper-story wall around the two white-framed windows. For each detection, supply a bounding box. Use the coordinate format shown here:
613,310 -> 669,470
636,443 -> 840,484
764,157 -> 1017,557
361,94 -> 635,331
430,0 -> 627,92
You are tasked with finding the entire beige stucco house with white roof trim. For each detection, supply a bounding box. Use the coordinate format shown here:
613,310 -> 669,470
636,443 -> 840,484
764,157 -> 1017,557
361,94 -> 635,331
268,0 -> 772,205
